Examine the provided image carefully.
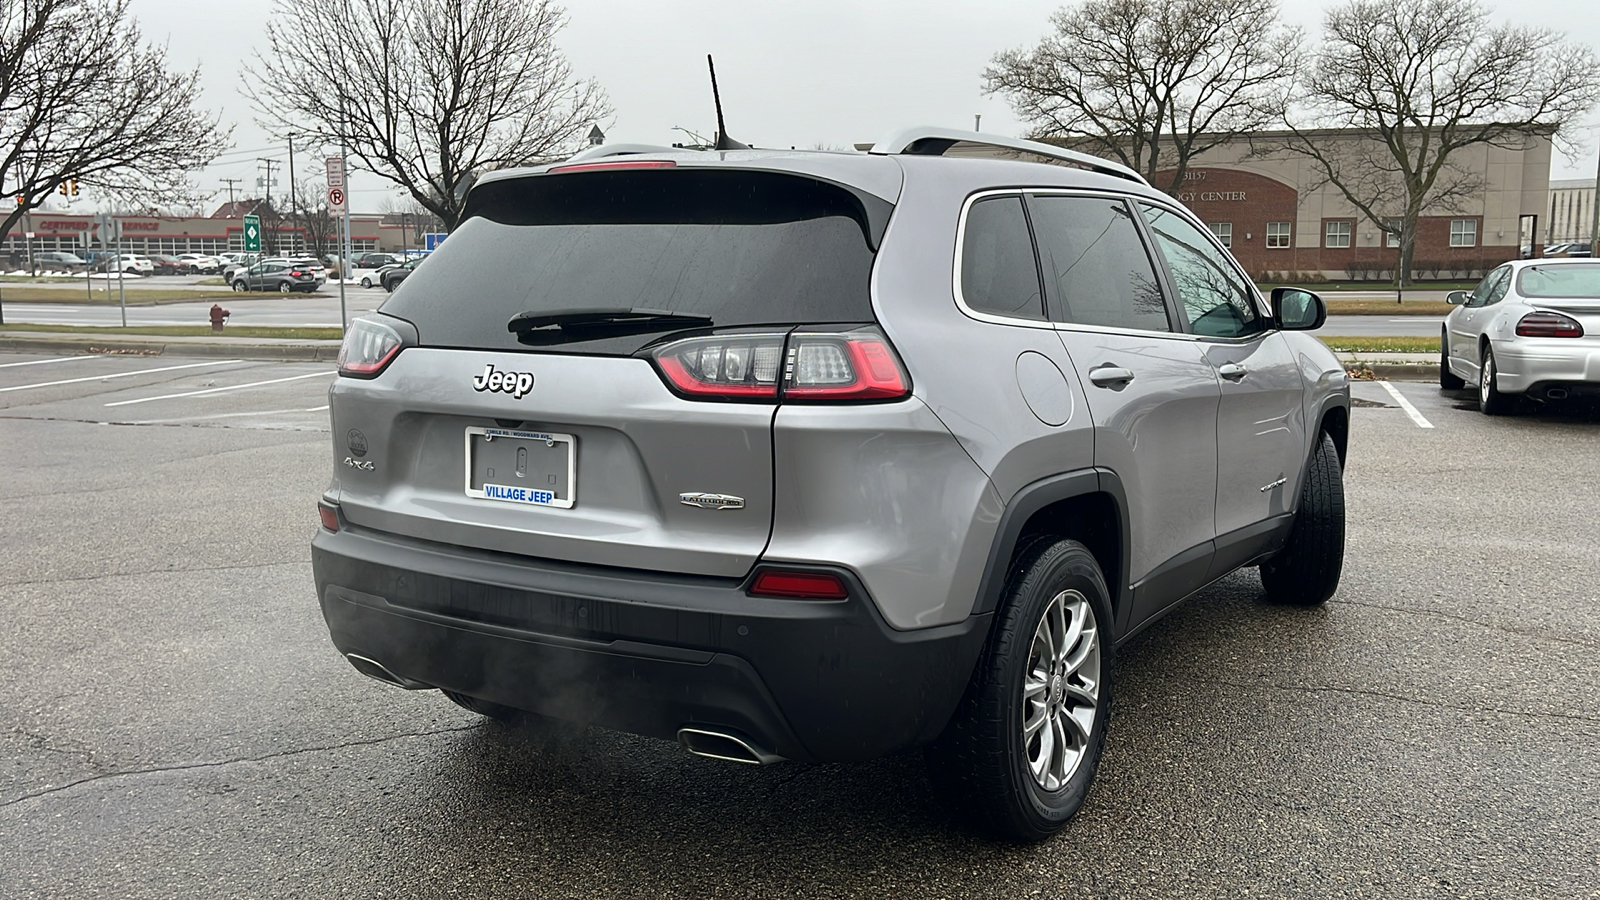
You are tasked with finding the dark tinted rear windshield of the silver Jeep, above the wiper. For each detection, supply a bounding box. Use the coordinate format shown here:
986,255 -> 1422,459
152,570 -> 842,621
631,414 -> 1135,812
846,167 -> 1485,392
382,168 -> 888,354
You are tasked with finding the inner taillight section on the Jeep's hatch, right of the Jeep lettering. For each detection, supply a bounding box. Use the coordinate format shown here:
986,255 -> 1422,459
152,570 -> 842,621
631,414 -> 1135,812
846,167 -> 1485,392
650,333 -> 784,400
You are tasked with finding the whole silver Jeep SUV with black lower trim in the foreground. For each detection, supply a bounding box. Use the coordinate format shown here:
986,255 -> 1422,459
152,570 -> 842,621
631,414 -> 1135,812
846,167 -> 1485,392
312,128 -> 1350,839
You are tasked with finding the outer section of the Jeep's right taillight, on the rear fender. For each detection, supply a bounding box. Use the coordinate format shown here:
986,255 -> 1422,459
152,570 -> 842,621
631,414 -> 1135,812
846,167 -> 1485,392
784,328 -> 910,402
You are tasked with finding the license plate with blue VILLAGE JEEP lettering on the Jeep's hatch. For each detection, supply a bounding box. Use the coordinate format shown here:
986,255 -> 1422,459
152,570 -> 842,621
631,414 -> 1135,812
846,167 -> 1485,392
467,426 -> 578,509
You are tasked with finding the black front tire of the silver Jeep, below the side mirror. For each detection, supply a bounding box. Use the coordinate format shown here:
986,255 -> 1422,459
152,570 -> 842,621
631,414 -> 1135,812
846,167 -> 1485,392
1261,432 -> 1344,607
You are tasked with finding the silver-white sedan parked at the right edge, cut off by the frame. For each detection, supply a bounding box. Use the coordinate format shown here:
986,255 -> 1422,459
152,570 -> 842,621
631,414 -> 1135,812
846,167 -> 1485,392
1438,258 -> 1600,415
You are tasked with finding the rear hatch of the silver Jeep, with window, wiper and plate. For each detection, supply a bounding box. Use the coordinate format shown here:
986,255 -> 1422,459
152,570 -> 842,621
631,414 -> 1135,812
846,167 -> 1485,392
331,163 -> 890,577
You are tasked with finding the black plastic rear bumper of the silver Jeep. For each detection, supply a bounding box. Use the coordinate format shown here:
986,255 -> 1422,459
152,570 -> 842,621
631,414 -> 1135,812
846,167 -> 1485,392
312,528 -> 989,761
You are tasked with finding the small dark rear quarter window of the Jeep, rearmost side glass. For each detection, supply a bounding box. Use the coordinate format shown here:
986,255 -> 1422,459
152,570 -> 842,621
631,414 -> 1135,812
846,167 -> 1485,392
962,195 -> 1045,319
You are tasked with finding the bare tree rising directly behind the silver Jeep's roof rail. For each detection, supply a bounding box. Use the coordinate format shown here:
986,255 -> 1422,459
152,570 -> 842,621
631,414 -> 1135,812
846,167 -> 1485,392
984,0 -> 1301,191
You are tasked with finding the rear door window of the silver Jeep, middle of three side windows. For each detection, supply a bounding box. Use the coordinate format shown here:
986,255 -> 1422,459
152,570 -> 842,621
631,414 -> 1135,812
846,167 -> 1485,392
1027,194 -> 1171,331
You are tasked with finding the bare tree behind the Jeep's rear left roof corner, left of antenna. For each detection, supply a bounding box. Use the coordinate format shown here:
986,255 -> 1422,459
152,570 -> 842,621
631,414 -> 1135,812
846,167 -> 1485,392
245,0 -> 611,227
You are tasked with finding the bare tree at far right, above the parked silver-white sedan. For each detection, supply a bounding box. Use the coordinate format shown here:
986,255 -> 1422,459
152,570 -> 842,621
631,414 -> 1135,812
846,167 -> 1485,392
1290,0 -> 1600,283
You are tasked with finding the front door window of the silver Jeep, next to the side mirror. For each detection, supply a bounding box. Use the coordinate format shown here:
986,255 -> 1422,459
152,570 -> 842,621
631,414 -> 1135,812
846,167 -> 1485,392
1139,203 -> 1266,338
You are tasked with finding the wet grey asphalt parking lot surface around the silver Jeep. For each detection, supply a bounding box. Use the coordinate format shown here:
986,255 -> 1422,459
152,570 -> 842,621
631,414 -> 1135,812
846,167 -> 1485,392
0,354 -> 1600,898
